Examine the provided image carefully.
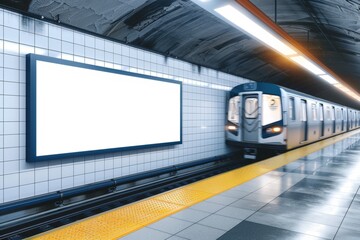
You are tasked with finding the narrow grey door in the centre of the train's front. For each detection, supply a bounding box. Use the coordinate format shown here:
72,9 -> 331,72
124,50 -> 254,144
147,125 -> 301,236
242,94 -> 259,142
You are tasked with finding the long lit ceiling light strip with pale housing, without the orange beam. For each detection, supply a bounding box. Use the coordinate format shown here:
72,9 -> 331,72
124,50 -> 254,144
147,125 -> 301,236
192,0 -> 360,100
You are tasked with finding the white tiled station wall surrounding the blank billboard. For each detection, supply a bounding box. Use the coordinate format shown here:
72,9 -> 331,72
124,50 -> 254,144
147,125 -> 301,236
0,9 -> 253,203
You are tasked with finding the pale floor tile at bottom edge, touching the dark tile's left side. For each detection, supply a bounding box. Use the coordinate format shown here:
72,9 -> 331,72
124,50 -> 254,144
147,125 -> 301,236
177,224 -> 225,240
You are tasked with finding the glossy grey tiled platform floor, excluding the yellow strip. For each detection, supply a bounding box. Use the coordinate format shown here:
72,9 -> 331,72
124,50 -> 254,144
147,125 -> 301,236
121,134 -> 360,240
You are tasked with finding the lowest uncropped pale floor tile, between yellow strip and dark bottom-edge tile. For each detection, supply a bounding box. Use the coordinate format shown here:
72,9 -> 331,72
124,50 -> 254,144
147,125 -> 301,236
147,217 -> 193,234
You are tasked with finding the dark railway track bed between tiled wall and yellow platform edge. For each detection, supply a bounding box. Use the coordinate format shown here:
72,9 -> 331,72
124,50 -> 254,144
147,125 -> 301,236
0,153 -> 274,240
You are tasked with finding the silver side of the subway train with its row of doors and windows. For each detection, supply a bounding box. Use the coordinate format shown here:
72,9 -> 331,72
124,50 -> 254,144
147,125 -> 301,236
282,87 -> 354,149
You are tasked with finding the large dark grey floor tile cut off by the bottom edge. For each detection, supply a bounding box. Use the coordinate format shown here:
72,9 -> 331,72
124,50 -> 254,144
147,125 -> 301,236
219,221 -> 322,240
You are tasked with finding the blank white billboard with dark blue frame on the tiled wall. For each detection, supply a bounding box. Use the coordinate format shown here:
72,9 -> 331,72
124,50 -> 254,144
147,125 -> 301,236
27,55 -> 181,161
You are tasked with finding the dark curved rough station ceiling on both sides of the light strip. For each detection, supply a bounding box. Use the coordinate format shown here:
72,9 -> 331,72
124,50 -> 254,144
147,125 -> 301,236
1,0 -> 360,108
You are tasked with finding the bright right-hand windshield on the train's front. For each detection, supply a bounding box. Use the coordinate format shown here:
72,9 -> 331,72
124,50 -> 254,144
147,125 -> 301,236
262,94 -> 282,126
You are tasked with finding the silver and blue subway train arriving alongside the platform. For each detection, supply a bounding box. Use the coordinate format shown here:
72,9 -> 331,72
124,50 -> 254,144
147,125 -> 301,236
226,82 -> 360,159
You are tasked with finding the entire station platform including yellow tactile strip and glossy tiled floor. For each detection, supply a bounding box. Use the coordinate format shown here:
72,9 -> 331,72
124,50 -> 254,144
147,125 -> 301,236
32,130 -> 360,240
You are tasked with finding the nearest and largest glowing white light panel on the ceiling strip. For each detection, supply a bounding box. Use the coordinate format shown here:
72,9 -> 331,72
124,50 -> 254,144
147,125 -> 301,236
215,5 -> 296,56
